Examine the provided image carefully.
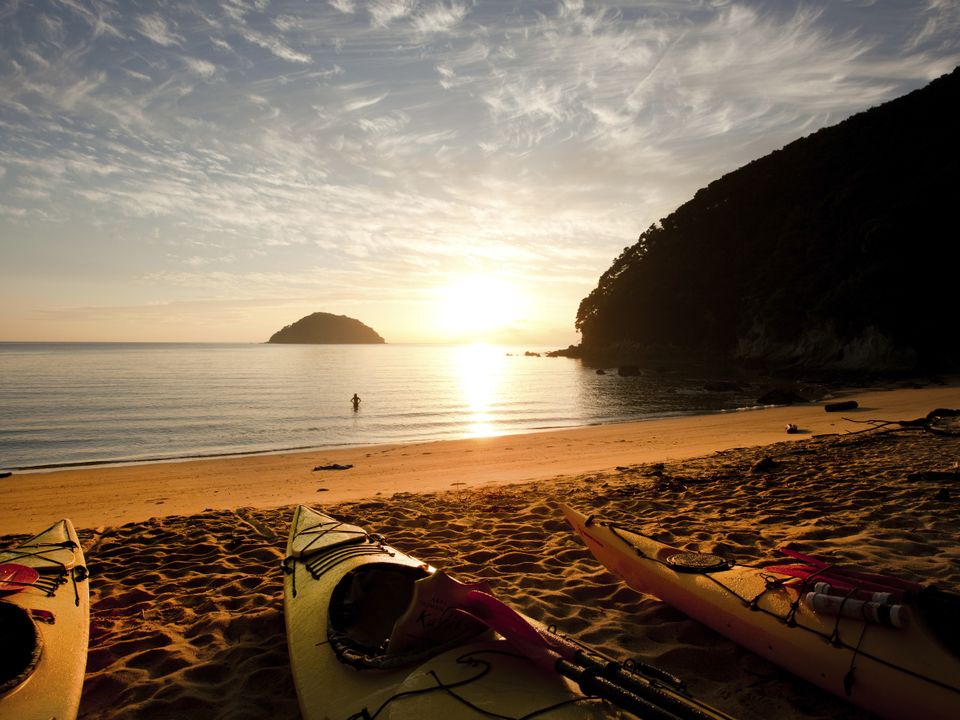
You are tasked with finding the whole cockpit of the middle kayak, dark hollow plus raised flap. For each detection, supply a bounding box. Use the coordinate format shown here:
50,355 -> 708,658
327,563 -> 489,669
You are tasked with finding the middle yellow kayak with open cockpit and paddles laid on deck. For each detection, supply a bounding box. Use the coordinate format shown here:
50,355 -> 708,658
284,505 -> 729,720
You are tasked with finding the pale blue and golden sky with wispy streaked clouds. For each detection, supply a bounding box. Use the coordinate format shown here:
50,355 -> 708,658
0,0 -> 960,347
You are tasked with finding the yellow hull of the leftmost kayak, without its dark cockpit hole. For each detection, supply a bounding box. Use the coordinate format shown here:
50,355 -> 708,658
0,519 -> 90,720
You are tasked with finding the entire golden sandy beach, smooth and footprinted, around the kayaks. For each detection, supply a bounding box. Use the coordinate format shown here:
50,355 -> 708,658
0,383 -> 960,720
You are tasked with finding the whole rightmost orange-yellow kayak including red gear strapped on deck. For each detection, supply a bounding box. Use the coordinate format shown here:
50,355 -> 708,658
562,505 -> 960,720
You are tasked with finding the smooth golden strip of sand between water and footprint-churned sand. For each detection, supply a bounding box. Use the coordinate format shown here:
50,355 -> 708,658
0,382 -> 960,534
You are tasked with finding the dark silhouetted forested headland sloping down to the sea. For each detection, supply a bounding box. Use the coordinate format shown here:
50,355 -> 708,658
577,69 -> 960,369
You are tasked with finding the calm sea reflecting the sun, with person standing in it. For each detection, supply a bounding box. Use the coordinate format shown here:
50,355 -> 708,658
0,343 -> 755,470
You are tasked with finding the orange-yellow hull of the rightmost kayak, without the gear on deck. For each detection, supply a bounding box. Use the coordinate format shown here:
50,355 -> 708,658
562,506 -> 960,720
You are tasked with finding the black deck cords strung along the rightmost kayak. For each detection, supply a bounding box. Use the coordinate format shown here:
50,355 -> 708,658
585,515 -> 960,694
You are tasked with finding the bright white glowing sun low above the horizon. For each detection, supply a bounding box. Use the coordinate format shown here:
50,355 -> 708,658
437,275 -> 525,342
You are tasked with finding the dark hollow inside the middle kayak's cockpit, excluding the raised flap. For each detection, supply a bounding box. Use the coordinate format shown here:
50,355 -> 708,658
327,563 -> 429,669
